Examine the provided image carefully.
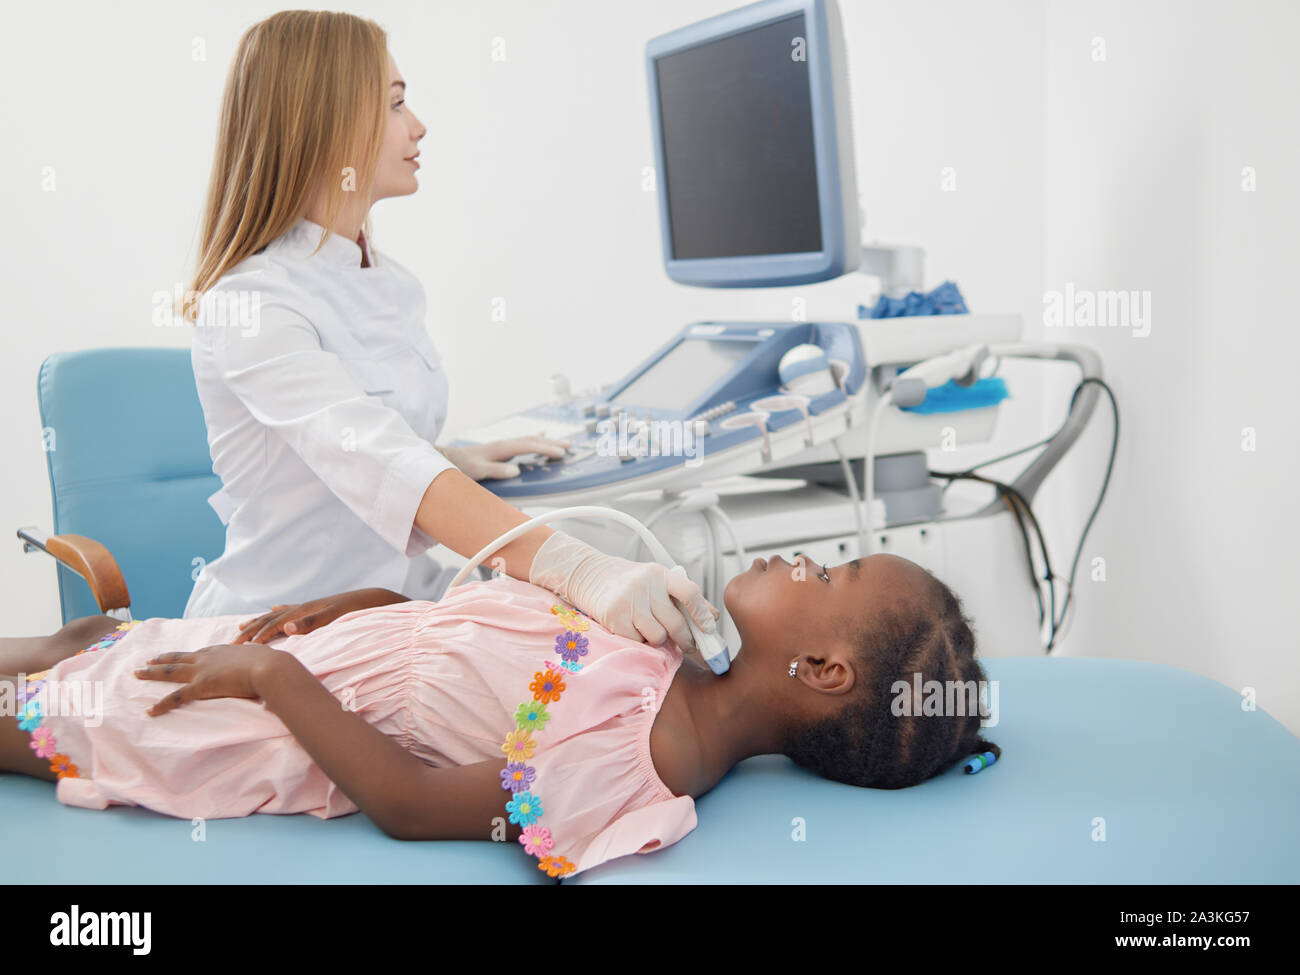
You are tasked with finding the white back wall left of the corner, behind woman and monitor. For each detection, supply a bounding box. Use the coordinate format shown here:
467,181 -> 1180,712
0,0 -> 1043,618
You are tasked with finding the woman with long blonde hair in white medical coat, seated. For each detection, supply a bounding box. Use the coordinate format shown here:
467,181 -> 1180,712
185,10 -> 718,650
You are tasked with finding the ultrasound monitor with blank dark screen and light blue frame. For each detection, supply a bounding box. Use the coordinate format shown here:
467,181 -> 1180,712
646,0 -> 861,287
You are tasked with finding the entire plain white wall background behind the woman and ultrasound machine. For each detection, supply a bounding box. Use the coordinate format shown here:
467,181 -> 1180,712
0,0 -> 1300,728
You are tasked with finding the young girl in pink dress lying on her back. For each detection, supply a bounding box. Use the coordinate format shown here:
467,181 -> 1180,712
0,554 -> 1000,876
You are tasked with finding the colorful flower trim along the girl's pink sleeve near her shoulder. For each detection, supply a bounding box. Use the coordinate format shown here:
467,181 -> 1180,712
501,605 -> 592,876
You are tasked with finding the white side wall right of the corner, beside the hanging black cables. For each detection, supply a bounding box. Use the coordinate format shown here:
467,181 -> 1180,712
1039,0 -> 1300,732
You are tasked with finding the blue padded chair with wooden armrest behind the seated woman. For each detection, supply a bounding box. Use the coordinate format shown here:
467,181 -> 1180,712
22,348 -> 225,623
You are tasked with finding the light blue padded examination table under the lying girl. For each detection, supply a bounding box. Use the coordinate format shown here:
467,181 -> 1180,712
0,657 -> 1300,884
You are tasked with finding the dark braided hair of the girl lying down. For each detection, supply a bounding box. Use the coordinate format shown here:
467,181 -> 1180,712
783,572 -> 1002,789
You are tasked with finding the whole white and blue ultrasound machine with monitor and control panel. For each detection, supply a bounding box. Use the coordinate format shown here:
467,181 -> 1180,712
454,0 -> 1101,654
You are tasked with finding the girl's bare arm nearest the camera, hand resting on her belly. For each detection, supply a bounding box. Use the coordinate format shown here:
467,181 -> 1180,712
137,644 -> 520,841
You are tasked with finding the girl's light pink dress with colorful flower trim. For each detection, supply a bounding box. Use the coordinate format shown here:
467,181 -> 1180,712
15,576 -> 696,875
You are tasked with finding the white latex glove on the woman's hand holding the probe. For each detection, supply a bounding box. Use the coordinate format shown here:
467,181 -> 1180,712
528,532 -> 719,651
